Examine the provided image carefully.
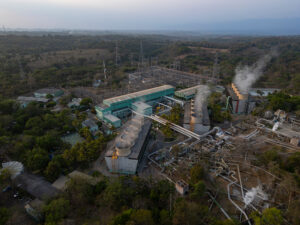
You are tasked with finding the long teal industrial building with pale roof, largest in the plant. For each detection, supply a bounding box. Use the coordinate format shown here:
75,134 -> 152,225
95,85 -> 175,128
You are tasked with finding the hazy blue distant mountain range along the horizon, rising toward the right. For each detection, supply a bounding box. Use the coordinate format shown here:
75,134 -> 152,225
0,18 -> 300,36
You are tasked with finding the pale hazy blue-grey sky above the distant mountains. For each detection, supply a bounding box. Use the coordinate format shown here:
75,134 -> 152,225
0,0 -> 300,30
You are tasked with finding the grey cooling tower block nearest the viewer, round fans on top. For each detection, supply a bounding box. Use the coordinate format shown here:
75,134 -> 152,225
105,116 -> 151,174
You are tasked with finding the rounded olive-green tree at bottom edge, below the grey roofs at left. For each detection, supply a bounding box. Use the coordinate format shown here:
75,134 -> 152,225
43,198 -> 70,224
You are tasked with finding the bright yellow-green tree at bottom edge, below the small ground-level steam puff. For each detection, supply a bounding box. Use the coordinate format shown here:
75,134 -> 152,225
251,208 -> 283,225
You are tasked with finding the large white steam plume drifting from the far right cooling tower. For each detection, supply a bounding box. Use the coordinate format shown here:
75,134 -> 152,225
234,50 -> 278,93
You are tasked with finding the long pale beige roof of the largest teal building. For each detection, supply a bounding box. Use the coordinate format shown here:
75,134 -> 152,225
103,85 -> 174,105
